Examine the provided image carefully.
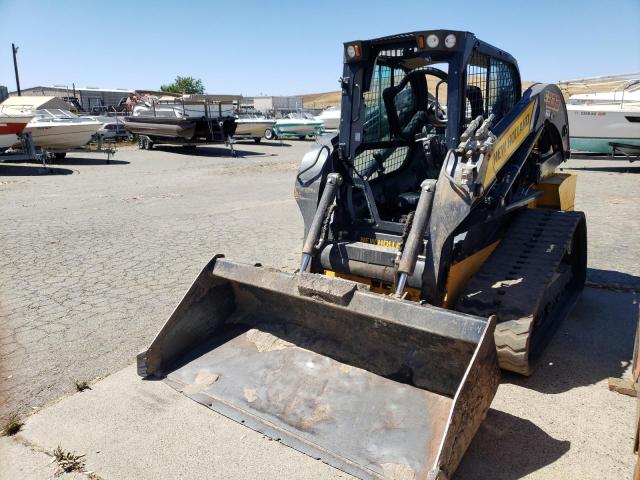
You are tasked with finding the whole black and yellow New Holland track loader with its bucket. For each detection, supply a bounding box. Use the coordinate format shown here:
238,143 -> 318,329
138,30 -> 586,480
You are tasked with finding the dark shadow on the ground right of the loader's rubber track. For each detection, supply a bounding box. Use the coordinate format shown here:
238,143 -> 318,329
502,278 -> 640,394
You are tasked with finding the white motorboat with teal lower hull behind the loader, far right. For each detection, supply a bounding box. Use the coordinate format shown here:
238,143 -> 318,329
567,80 -> 640,154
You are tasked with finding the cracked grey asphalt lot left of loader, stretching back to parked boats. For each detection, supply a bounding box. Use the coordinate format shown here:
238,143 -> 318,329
0,142 -> 304,417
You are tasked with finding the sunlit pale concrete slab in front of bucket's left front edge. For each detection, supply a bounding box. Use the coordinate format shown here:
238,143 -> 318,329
16,366 -> 351,480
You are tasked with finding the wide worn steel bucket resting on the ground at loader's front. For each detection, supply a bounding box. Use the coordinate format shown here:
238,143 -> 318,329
138,256 -> 499,480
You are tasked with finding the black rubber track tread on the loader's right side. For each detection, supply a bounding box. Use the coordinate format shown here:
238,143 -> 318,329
455,209 -> 583,375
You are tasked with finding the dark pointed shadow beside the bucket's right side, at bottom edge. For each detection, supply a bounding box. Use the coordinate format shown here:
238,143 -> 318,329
452,409 -> 571,480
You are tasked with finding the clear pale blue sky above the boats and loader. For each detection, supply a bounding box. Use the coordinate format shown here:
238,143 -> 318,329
0,0 -> 640,95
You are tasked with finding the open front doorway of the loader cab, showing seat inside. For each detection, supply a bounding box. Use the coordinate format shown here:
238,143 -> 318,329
351,56 -> 448,226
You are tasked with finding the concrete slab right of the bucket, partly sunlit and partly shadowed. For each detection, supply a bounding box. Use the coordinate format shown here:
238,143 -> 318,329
455,288 -> 640,480
